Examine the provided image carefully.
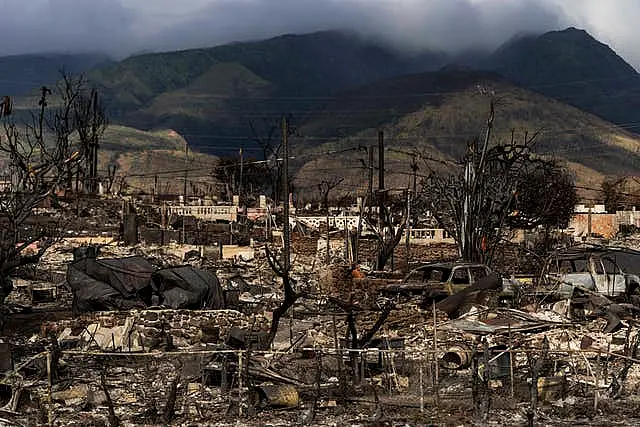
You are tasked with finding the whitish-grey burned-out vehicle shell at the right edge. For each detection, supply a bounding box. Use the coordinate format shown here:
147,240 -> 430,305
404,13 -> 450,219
538,246 -> 640,299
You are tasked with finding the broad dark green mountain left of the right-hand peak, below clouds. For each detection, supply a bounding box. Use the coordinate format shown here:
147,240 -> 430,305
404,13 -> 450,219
82,31 -> 447,152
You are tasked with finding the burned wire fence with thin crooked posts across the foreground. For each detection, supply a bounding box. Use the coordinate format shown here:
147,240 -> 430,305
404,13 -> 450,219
1,340 -> 640,425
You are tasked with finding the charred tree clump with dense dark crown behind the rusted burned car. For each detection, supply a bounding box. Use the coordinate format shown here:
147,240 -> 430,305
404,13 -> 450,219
419,101 -> 577,263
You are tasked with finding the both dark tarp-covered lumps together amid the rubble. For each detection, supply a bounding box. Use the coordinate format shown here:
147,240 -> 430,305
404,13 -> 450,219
67,256 -> 224,312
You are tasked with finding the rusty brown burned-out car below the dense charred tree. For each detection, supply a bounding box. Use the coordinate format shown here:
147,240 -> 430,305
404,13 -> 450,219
383,262 -> 518,301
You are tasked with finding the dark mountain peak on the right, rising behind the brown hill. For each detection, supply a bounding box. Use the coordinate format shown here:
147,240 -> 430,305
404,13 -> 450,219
482,28 -> 640,125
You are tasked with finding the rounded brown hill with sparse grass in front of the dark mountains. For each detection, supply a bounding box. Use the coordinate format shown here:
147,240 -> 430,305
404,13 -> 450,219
291,70 -> 640,198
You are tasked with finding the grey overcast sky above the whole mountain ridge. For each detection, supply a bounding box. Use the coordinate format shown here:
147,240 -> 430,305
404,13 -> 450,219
0,0 -> 640,69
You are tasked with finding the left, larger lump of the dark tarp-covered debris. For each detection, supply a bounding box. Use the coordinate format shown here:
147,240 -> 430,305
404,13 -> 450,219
67,256 -> 153,312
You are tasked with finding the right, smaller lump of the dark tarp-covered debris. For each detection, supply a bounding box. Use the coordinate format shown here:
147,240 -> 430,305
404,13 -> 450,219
152,266 -> 224,310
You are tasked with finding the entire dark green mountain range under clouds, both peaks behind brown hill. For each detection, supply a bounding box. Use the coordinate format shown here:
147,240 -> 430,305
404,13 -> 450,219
82,28 -> 640,155
